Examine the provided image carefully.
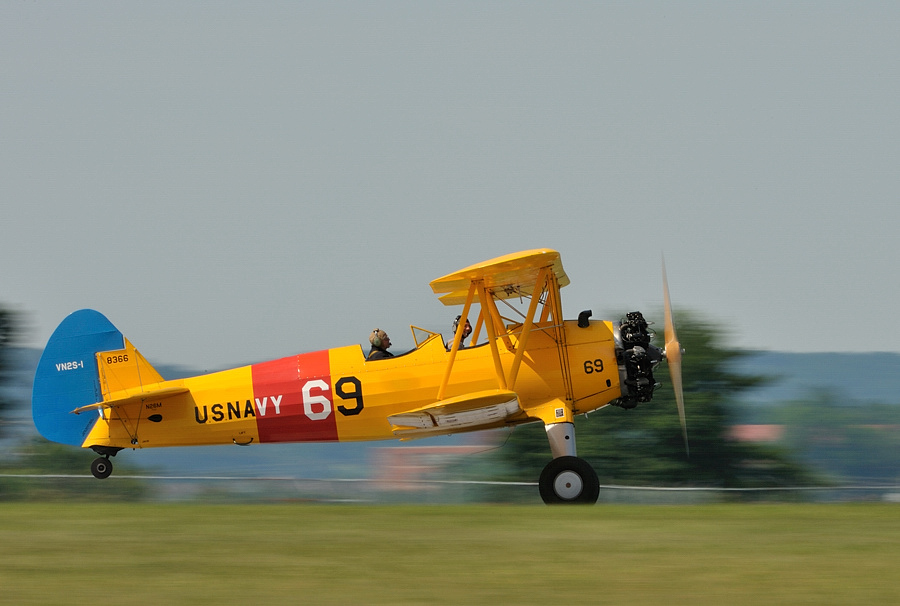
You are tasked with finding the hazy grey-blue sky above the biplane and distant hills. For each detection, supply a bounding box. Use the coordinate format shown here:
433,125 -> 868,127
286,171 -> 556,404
0,1 -> 900,369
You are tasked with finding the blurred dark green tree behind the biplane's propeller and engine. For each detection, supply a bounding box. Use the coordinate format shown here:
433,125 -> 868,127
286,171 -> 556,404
498,313 -> 812,488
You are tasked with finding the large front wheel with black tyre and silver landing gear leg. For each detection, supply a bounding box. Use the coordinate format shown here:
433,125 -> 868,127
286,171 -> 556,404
538,423 -> 600,505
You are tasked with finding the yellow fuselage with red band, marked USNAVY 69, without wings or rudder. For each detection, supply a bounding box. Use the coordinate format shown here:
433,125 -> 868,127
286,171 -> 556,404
83,321 -> 621,448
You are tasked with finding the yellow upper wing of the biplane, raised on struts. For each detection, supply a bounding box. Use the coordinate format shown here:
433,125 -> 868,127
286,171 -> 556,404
431,248 -> 569,305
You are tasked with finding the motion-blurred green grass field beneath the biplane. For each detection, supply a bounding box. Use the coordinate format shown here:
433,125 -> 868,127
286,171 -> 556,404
0,504 -> 900,606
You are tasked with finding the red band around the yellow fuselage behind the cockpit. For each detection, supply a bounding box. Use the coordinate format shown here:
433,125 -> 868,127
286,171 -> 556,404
251,350 -> 337,442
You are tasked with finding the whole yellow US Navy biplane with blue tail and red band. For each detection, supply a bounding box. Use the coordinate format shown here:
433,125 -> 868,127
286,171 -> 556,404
32,249 -> 687,503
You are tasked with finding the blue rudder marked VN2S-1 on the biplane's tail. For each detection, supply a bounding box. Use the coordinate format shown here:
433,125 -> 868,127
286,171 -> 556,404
31,309 -> 125,446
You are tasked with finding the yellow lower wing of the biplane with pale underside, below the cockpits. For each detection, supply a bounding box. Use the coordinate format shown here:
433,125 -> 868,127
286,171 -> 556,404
388,389 -> 522,437
